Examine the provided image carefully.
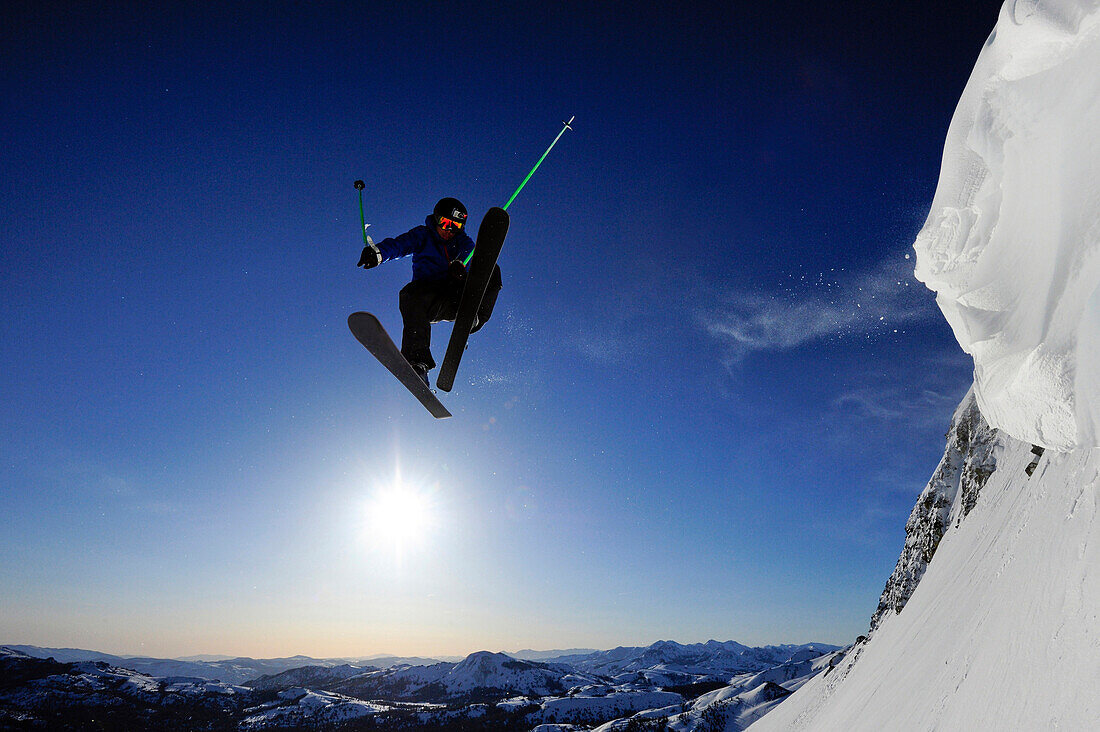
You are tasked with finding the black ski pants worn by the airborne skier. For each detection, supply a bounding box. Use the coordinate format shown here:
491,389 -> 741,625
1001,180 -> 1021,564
399,265 -> 501,369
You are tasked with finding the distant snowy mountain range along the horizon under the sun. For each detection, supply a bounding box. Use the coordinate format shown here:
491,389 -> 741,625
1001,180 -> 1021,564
0,641 -> 838,730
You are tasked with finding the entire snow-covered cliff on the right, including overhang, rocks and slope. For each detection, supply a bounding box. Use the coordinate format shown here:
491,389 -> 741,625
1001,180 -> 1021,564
752,0 -> 1100,732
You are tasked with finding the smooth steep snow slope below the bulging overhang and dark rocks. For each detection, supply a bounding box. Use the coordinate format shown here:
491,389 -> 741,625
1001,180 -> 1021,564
751,413 -> 1100,732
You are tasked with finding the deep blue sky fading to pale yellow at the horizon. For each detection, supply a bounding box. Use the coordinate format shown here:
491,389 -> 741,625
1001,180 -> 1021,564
0,1 -> 999,657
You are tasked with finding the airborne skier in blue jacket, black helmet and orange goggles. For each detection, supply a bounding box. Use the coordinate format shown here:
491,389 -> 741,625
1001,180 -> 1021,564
356,198 -> 501,385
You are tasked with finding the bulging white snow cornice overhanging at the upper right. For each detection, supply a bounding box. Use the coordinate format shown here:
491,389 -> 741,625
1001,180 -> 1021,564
914,0 -> 1100,450
